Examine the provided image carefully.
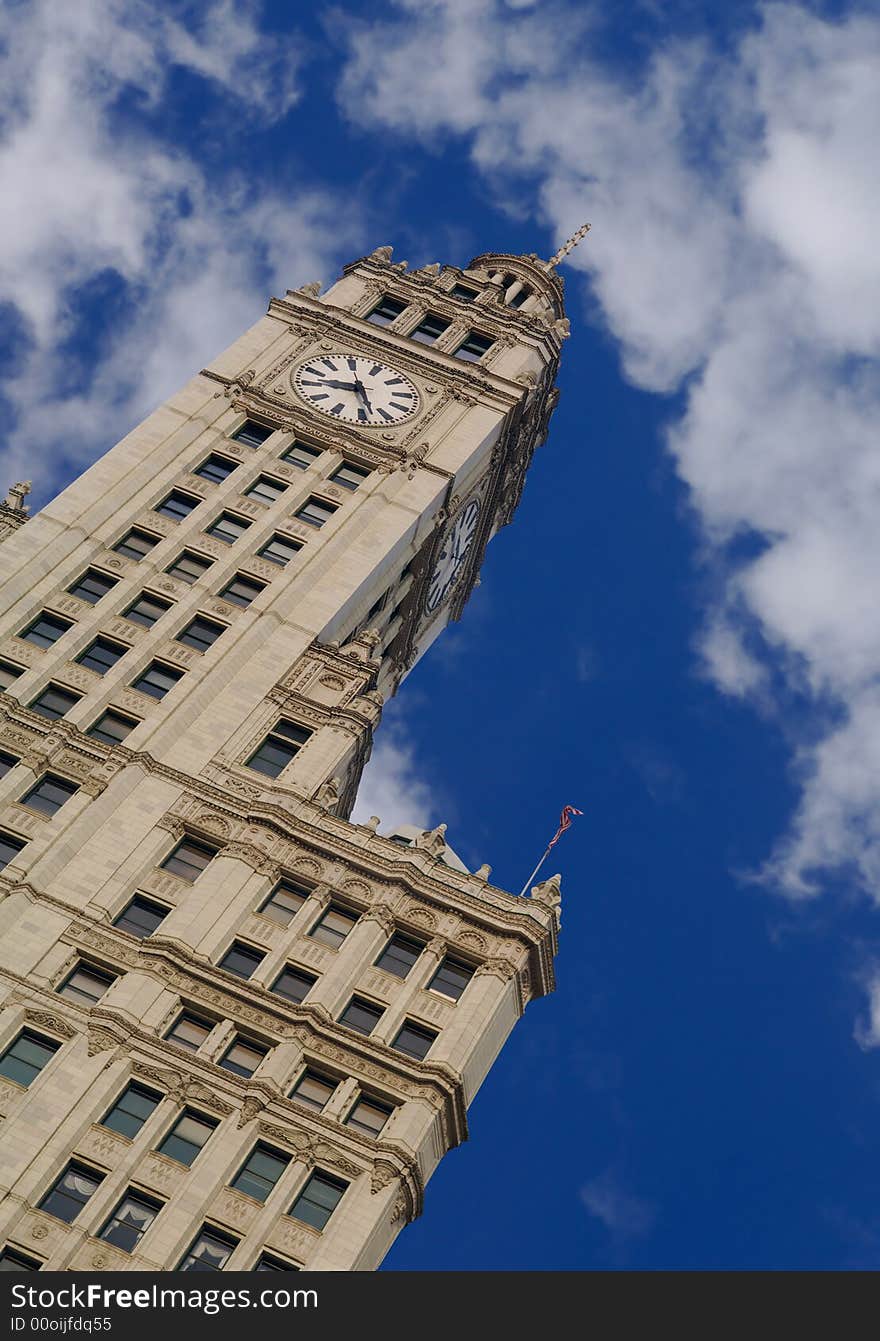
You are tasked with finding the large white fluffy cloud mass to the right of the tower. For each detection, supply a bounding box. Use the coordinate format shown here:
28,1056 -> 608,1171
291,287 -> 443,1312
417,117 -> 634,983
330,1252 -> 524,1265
341,0 -> 880,922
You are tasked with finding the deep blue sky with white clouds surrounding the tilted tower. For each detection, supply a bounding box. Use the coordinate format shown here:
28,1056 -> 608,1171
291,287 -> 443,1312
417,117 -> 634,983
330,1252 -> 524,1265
0,0 -> 880,1270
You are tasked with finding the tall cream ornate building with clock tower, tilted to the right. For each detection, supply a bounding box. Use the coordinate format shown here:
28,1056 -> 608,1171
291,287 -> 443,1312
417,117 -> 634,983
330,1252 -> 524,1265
0,247 -> 567,1271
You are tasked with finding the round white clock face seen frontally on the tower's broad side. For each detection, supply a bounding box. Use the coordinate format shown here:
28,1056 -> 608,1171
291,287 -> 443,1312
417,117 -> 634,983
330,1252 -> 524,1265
294,354 -> 419,428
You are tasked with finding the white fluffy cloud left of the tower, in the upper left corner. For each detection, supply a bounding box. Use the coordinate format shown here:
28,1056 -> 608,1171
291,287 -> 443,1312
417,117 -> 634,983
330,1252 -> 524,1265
0,0 -> 355,503
